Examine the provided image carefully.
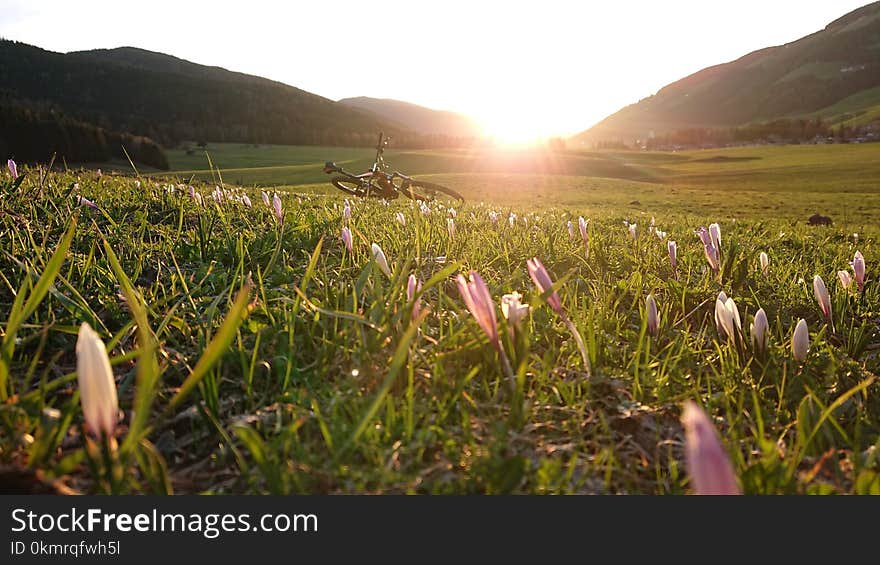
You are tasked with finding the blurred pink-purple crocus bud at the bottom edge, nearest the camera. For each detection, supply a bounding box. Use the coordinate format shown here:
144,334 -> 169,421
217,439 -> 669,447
681,400 -> 742,495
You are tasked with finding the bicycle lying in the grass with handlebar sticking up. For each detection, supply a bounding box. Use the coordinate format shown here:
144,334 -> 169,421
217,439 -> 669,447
324,132 -> 464,202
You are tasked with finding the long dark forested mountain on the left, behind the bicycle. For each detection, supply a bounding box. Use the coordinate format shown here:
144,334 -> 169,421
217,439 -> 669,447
0,40 -> 434,146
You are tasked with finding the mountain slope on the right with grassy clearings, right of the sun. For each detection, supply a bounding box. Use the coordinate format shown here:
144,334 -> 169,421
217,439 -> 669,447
574,2 -> 880,143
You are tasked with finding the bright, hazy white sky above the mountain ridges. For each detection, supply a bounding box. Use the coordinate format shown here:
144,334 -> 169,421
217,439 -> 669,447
0,0 -> 868,139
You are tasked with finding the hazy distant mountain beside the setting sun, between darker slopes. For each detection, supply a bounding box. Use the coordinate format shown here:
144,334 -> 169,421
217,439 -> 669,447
339,96 -> 481,137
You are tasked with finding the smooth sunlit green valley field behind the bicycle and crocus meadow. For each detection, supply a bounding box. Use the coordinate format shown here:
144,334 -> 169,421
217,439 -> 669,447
160,144 -> 880,220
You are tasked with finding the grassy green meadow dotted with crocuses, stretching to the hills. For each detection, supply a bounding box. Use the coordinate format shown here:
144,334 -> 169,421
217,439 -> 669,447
0,144 -> 880,494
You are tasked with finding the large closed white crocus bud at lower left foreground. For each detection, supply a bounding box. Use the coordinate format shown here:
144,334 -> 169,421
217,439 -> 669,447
76,322 -> 119,437
